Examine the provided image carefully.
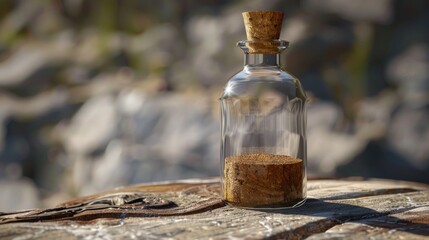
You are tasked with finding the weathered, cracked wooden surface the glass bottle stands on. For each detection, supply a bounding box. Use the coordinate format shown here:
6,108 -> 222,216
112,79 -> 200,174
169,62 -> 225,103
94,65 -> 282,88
0,179 -> 429,239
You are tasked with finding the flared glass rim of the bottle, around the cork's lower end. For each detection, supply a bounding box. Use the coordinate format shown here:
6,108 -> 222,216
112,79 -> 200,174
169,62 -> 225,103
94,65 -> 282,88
237,40 -> 289,54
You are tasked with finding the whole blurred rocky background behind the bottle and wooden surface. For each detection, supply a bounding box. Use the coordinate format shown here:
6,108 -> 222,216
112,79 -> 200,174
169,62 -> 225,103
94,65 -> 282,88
0,0 -> 429,211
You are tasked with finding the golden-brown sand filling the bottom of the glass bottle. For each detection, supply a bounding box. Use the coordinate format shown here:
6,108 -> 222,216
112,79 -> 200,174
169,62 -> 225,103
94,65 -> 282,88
223,153 -> 304,208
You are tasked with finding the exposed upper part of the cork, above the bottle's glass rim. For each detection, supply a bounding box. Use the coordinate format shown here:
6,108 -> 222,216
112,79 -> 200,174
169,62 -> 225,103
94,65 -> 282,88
243,11 -> 283,40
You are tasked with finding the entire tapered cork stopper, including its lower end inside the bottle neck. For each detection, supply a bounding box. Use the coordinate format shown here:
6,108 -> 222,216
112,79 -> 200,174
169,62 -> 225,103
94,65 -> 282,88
243,11 -> 283,54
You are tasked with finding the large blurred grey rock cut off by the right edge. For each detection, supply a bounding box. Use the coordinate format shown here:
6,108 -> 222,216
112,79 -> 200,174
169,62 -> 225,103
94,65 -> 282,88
386,44 -> 429,170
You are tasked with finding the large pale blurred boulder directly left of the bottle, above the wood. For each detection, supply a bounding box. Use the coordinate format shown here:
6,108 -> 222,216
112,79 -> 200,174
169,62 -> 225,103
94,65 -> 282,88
70,92 -> 219,194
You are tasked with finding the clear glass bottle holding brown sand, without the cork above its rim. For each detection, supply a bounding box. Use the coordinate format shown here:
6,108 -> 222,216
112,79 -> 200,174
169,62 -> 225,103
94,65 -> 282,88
220,40 -> 307,208
